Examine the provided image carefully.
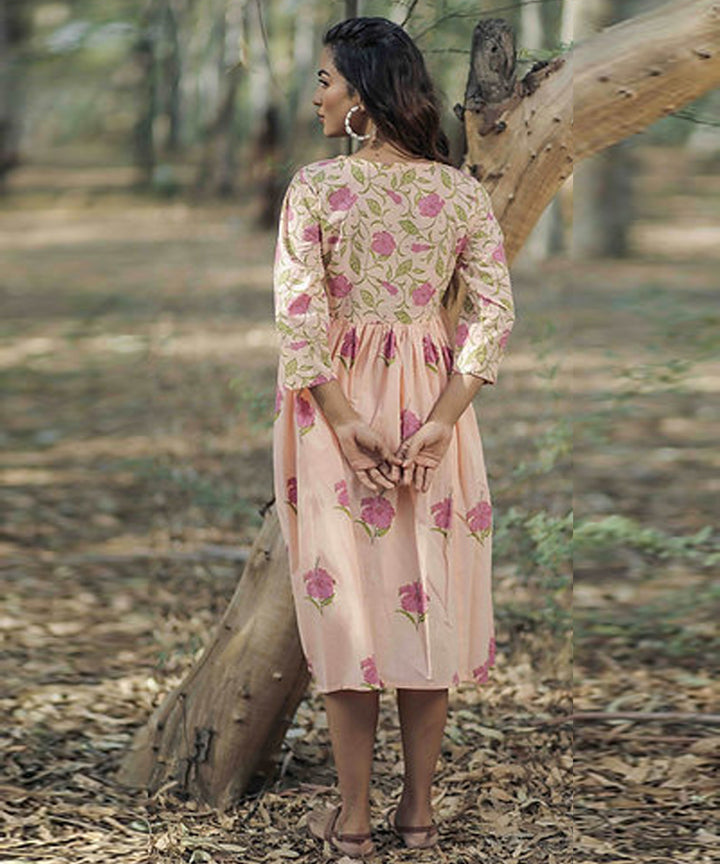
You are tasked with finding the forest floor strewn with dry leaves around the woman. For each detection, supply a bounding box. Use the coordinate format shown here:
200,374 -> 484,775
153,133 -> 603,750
0,150 -> 720,864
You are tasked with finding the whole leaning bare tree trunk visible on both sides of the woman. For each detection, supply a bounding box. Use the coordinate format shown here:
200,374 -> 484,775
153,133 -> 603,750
120,0 -> 720,809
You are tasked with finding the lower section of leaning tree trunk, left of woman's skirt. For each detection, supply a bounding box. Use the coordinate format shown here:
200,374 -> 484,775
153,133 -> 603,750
117,507 -> 310,810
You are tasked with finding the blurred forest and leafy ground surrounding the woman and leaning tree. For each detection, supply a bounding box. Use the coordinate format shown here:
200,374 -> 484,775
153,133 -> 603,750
0,0 -> 720,864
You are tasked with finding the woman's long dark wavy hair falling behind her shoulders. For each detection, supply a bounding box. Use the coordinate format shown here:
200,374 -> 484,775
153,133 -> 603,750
323,18 -> 452,165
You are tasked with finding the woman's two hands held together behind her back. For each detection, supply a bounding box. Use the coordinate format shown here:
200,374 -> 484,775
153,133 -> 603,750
335,419 -> 453,492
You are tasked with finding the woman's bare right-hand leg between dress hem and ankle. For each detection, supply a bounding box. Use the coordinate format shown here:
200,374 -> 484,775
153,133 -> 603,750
397,688 -> 448,827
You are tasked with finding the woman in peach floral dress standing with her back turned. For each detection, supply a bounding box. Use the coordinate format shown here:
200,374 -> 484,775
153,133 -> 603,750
273,18 -> 514,857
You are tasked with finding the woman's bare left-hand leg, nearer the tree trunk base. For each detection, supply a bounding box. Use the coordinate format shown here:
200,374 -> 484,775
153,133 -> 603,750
325,690 -> 379,834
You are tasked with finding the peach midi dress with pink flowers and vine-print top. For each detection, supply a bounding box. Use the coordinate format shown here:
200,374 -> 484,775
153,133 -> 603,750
273,156 -> 515,692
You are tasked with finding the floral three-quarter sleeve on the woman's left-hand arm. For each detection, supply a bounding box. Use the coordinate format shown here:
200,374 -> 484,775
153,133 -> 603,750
273,168 -> 336,390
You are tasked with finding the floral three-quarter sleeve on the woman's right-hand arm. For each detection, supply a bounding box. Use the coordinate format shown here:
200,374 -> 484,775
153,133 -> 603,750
452,181 -> 515,384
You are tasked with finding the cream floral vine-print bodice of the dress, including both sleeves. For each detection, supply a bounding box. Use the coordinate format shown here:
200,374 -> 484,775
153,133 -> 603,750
273,156 -> 515,389
